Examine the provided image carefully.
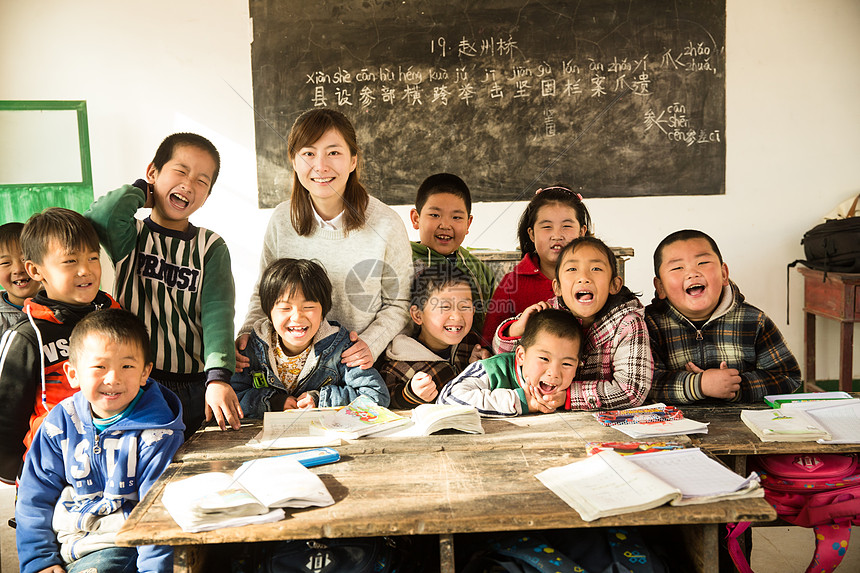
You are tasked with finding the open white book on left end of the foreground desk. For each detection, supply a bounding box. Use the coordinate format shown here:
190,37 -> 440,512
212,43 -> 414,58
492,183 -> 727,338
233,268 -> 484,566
162,456 -> 334,532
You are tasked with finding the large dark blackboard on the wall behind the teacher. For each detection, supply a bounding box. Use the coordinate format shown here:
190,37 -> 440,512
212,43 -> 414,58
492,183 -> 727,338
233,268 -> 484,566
250,0 -> 726,207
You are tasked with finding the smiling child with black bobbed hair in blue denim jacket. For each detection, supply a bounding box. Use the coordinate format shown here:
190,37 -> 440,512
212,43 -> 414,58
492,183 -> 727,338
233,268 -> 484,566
230,259 -> 390,418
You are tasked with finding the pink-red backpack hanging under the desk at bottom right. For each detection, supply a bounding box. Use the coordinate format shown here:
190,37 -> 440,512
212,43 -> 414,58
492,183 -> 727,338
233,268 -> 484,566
727,454 -> 860,573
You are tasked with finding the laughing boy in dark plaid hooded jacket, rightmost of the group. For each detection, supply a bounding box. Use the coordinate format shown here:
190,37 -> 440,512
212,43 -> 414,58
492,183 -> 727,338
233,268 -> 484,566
645,230 -> 801,404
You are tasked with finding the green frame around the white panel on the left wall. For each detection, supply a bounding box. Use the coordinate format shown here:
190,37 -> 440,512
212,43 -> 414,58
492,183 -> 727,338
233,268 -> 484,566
0,100 -> 93,223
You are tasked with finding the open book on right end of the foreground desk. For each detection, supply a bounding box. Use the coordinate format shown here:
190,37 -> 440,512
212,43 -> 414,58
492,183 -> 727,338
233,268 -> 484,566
535,448 -> 764,521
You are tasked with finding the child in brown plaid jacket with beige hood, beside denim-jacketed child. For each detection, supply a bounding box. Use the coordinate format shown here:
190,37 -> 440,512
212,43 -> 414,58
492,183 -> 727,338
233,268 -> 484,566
376,263 -> 490,409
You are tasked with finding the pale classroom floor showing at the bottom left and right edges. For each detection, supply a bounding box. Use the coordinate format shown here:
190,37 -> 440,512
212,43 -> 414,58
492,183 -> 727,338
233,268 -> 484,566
0,484 -> 860,573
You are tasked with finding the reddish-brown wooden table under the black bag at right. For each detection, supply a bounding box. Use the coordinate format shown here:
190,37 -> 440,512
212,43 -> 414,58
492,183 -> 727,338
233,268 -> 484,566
797,267 -> 860,392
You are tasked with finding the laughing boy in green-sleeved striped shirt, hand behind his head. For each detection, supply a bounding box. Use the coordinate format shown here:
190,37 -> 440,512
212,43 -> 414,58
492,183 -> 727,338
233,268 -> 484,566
85,133 -> 243,437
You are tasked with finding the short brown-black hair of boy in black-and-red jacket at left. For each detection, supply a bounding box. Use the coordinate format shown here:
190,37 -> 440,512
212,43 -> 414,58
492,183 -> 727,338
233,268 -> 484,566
21,207 -> 99,264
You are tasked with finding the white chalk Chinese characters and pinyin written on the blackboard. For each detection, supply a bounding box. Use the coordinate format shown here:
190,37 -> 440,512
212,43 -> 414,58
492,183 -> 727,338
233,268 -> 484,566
305,36 -> 720,146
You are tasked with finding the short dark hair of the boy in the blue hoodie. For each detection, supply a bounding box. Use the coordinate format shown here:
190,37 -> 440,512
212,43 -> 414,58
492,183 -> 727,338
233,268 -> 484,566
69,308 -> 152,365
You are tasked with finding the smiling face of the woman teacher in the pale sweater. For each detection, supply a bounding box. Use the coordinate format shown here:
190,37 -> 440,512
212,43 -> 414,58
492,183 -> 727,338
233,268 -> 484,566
292,128 -> 358,213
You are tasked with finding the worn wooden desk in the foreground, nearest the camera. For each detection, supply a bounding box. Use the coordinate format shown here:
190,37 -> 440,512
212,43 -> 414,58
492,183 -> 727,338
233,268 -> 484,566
116,446 -> 776,573
